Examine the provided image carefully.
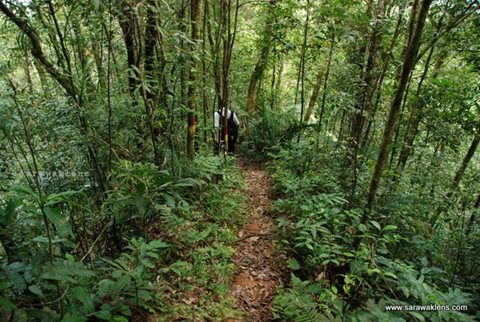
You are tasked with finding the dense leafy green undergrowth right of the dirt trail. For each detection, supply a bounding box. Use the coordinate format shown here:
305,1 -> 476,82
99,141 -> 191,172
269,141 -> 475,321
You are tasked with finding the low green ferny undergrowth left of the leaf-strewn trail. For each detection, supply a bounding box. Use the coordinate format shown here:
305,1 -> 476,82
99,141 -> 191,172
0,157 -> 245,321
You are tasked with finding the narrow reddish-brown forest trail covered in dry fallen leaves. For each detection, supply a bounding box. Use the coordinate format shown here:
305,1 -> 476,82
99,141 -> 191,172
230,161 -> 283,322
